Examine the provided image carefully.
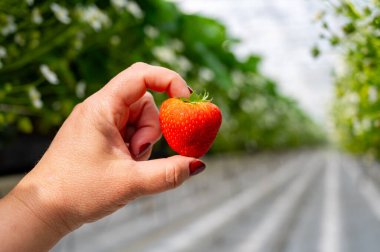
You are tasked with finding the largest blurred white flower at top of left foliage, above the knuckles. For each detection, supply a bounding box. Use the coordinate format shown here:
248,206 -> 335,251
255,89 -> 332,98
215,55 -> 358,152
79,4 -> 111,31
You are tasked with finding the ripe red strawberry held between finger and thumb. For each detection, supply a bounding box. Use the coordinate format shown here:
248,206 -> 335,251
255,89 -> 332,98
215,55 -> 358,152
160,92 -> 222,158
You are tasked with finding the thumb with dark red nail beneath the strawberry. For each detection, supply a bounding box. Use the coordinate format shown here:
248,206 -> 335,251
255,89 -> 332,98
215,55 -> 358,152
135,156 -> 206,195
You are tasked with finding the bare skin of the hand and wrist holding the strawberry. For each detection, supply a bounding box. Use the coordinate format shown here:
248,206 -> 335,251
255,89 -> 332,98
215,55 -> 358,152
0,63 -> 204,251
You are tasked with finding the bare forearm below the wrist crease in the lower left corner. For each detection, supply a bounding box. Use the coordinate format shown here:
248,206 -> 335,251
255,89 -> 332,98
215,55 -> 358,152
0,185 -> 65,252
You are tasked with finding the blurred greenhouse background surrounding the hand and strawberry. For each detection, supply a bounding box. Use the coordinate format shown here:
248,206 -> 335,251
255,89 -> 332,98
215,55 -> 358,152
0,0 -> 380,252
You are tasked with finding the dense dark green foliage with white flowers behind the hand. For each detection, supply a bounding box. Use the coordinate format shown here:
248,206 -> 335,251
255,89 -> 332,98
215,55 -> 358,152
0,0 -> 321,154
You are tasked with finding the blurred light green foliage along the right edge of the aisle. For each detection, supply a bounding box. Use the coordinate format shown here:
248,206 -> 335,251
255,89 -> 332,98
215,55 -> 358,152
316,1 -> 380,158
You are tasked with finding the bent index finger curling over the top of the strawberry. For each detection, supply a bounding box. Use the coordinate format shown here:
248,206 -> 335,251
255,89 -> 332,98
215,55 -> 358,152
102,63 -> 190,106
